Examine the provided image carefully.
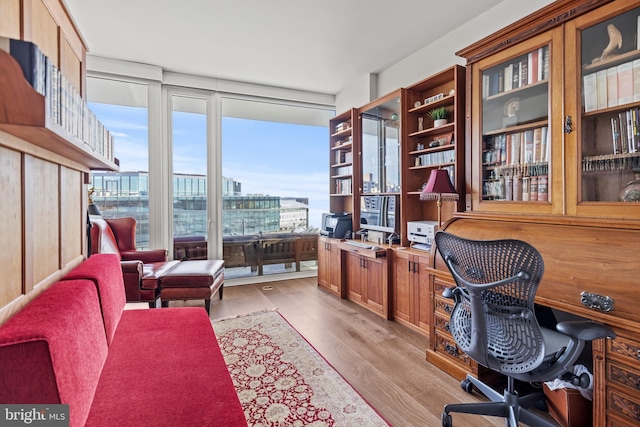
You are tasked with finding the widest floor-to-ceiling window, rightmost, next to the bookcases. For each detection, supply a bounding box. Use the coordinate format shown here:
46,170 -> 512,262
221,97 -> 332,277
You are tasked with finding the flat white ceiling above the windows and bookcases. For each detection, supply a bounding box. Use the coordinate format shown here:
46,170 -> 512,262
65,0 -> 502,94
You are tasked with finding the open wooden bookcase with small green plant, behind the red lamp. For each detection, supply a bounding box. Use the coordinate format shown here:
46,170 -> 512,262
400,65 -> 465,245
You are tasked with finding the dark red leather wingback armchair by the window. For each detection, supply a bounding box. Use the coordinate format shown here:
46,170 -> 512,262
91,217 -> 180,307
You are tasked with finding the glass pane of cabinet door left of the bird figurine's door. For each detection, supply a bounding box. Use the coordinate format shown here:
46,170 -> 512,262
482,45 -> 551,202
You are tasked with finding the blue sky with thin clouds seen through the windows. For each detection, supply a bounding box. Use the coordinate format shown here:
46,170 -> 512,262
90,103 -> 329,227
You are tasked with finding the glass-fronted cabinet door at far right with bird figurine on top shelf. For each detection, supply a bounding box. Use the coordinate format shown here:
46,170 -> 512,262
565,1 -> 640,219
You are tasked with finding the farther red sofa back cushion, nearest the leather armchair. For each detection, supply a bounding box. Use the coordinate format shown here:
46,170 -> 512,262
63,254 -> 126,344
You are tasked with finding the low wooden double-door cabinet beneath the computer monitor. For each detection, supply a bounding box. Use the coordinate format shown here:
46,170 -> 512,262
340,243 -> 390,319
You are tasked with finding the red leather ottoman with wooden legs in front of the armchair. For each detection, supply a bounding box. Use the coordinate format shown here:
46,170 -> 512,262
160,260 -> 224,313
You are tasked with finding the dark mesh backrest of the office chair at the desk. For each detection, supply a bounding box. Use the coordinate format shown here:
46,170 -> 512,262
436,232 -> 545,375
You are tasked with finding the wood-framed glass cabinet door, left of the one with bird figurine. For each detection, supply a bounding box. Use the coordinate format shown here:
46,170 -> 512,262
471,28 -> 563,214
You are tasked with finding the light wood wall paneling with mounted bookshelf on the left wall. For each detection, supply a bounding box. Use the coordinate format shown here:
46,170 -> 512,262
0,0 -> 118,323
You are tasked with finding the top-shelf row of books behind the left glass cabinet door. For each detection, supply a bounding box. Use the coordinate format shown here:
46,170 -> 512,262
482,46 -> 549,99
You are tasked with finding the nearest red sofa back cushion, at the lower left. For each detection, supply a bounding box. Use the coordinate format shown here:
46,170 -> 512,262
0,280 -> 107,426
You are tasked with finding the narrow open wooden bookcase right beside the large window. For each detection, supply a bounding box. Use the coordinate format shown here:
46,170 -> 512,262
329,108 -> 360,230
